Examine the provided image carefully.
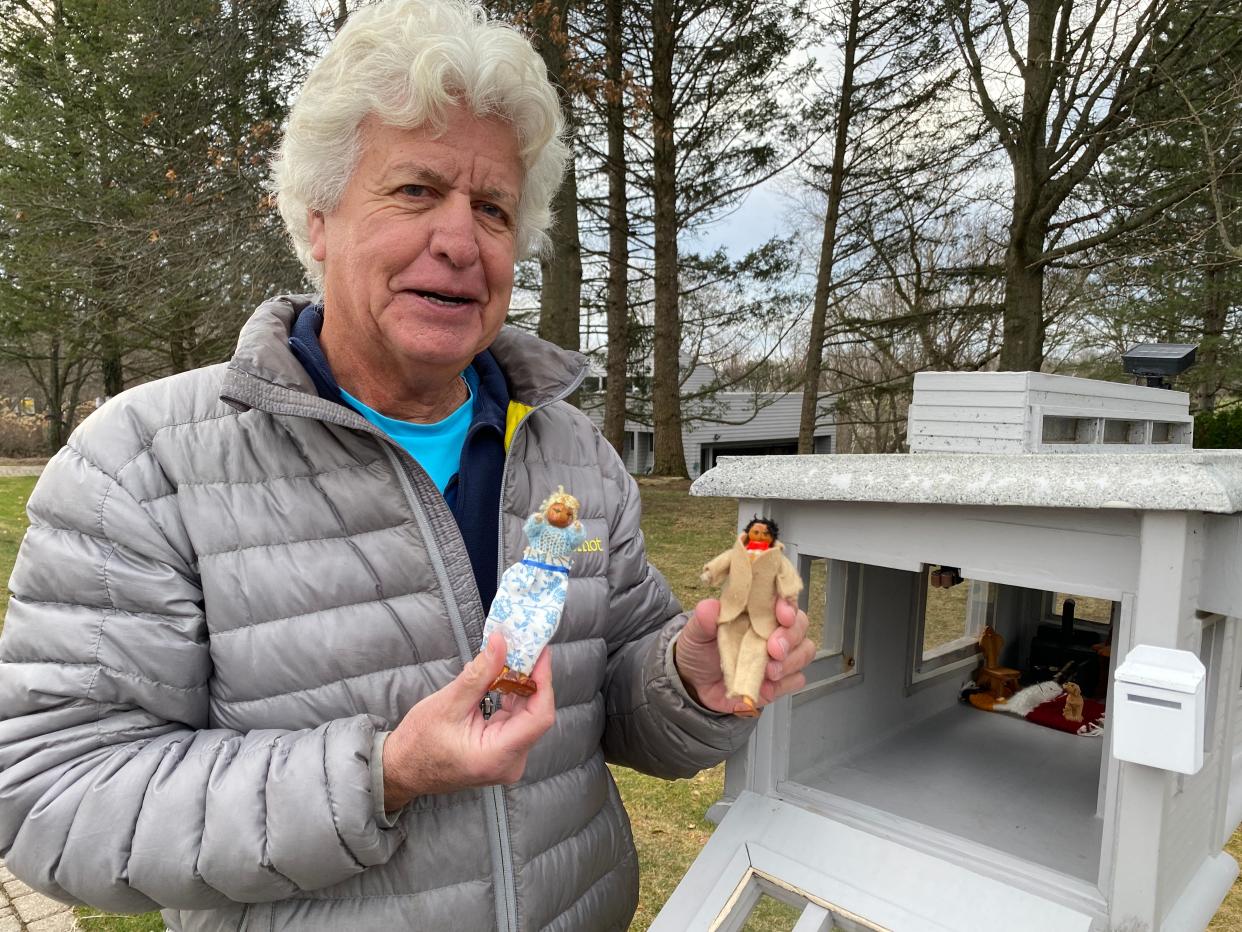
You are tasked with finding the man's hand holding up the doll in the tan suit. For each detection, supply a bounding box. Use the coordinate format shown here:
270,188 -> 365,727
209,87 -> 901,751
673,599 -> 815,712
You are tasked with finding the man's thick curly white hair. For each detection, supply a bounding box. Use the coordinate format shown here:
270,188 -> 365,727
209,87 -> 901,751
272,0 -> 569,287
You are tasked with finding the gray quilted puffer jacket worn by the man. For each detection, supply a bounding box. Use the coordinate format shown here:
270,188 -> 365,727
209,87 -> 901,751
0,298 -> 748,932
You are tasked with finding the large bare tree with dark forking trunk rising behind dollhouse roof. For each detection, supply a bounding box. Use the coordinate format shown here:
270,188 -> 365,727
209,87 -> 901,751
948,0 -> 1230,369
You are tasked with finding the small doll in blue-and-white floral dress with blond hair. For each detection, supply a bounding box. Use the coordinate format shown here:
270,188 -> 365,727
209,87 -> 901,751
483,486 -> 586,696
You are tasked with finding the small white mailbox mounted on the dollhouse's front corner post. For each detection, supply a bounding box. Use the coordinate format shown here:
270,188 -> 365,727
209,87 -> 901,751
1113,644 -> 1206,774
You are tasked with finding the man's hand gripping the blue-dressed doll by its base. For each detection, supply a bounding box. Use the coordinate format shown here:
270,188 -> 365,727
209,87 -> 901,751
384,633 -> 556,811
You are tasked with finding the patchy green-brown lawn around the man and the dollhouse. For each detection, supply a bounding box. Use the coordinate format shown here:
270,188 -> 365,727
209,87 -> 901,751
0,477 -> 1242,932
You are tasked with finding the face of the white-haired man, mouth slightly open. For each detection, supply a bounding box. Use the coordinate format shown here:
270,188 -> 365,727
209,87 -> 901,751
311,107 -> 523,388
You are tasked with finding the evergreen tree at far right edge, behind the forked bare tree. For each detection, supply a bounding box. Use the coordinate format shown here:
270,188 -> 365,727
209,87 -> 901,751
1093,0 -> 1242,411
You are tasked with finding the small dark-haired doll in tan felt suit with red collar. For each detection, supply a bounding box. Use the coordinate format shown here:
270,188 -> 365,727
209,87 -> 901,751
699,518 -> 802,716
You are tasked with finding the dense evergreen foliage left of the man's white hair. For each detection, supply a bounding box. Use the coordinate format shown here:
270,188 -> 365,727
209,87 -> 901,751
0,0 -> 302,445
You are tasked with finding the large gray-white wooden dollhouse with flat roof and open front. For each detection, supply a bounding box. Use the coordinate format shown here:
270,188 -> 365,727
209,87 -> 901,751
652,373 -> 1242,932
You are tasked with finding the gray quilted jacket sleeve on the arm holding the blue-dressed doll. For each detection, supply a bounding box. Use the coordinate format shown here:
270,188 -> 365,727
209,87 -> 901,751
0,447 -> 404,911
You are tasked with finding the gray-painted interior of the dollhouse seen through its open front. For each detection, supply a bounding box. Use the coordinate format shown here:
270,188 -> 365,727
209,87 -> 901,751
789,553 -> 1119,885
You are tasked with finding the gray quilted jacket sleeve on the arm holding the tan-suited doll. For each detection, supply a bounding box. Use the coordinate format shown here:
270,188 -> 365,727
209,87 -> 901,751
604,459 -> 754,778
